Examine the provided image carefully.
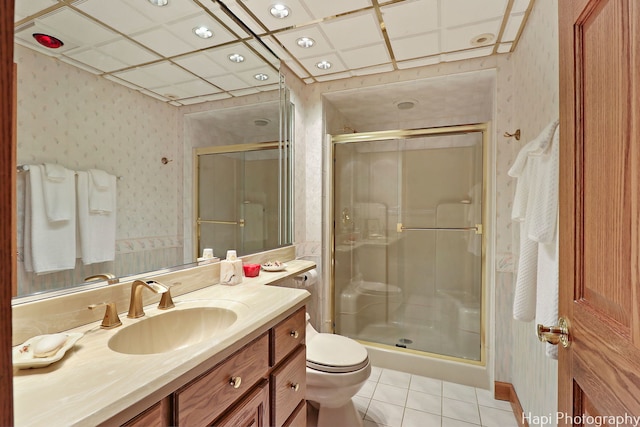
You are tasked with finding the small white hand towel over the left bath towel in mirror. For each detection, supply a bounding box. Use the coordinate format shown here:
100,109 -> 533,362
41,163 -> 76,222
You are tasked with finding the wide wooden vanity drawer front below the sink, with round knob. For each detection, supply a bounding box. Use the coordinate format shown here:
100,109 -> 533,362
175,334 -> 269,427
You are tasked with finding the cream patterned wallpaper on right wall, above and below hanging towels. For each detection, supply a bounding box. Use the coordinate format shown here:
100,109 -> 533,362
504,0 -> 560,422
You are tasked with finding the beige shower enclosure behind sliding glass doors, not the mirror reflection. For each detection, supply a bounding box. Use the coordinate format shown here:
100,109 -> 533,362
331,124 -> 487,363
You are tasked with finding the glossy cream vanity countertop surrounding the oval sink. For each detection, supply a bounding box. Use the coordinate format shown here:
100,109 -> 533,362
13,260 -> 315,427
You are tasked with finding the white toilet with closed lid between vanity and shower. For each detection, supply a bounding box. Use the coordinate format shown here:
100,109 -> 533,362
306,314 -> 371,427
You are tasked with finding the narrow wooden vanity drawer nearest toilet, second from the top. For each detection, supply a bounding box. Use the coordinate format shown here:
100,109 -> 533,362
271,346 -> 307,427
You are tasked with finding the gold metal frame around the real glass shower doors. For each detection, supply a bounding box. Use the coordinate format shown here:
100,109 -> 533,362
328,122 -> 491,366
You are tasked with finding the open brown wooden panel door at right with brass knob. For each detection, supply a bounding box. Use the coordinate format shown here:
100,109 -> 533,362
558,0 -> 640,425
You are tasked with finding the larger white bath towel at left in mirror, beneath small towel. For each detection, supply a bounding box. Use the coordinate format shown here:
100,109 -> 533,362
24,165 -> 76,274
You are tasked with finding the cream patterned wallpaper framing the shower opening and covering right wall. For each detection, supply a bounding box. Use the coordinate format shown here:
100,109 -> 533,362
284,0 -> 558,422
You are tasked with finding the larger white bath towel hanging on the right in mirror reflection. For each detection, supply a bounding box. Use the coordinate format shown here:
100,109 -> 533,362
77,172 -> 116,264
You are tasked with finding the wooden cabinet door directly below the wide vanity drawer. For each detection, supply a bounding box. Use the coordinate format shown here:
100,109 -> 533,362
214,380 -> 269,427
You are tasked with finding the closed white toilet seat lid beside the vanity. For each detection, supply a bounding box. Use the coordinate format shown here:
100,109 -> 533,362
307,333 -> 369,373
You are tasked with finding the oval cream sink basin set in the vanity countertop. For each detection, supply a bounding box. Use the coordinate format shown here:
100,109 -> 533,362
108,307 -> 238,354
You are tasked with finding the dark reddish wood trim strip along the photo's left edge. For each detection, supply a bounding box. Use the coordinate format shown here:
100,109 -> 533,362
0,0 -> 16,426
